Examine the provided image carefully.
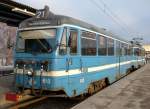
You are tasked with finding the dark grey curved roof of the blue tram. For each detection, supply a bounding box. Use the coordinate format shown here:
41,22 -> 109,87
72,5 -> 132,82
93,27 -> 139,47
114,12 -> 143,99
19,6 -> 129,43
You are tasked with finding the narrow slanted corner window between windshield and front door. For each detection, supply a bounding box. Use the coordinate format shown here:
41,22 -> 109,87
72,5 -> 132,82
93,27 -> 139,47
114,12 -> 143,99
59,28 -> 67,55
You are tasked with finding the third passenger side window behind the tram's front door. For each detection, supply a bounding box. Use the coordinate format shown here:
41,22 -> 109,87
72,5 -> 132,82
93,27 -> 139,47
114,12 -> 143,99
107,38 -> 114,55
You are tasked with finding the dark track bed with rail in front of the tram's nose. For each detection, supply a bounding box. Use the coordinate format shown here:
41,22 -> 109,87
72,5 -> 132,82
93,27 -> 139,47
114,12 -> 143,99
5,96 -> 84,109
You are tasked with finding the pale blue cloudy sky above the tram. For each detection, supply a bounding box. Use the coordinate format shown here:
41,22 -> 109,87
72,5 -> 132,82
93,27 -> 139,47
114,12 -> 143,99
14,0 -> 150,43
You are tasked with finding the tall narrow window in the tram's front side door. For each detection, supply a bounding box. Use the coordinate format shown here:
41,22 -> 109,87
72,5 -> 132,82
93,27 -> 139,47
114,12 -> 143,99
68,29 -> 78,55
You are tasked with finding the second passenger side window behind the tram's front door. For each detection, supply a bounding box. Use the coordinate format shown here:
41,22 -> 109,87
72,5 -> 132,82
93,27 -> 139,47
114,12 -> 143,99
98,36 -> 107,55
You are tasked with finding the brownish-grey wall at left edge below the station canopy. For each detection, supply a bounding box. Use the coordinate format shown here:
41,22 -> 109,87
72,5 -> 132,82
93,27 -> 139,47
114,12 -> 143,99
0,22 -> 17,66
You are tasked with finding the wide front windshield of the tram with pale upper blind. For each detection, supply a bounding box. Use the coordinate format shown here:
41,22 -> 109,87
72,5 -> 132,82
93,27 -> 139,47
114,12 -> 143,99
16,29 -> 56,53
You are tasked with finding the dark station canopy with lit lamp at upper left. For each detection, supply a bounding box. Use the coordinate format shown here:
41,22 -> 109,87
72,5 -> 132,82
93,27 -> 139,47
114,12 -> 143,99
0,0 -> 36,27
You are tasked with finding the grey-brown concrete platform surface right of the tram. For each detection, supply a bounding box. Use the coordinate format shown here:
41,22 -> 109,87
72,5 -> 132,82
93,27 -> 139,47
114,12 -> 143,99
72,64 -> 150,109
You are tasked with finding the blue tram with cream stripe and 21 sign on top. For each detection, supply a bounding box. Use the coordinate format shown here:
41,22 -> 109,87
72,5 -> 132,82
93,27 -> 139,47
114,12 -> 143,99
14,6 -> 144,97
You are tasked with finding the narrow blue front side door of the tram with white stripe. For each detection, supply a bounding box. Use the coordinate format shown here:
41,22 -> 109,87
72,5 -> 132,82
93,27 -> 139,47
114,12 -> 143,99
66,28 -> 84,88
